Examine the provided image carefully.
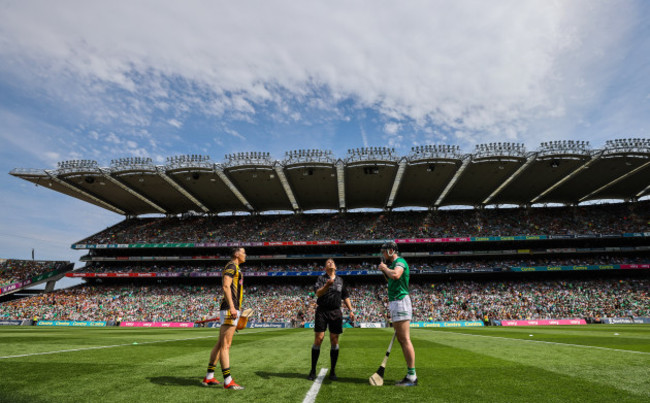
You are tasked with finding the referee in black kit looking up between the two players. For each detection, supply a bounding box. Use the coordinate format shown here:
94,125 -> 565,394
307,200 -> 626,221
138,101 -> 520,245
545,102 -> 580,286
307,259 -> 354,381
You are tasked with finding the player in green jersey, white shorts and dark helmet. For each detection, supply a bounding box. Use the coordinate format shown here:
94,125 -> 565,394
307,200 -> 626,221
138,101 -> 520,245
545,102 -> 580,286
379,242 -> 418,386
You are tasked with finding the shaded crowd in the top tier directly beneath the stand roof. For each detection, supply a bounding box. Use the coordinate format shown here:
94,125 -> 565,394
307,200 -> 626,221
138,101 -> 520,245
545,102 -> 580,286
80,201 -> 650,244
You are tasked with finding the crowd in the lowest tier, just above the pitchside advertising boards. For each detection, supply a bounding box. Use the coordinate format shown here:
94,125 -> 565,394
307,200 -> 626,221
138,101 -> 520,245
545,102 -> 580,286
0,276 -> 650,324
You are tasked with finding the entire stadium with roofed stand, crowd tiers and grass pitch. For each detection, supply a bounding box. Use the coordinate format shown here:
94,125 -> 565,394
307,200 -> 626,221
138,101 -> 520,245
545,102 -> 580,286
0,139 -> 650,402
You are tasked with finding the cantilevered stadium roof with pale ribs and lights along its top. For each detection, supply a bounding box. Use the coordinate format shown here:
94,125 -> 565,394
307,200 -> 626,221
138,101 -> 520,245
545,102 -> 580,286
10,139 -> 650,215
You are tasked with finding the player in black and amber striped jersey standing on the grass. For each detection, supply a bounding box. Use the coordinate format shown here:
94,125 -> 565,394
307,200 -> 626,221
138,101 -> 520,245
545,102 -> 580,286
202,248 -> 246,390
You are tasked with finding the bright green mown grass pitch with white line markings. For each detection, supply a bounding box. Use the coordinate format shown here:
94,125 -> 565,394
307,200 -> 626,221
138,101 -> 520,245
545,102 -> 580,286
0,325 -> 650,403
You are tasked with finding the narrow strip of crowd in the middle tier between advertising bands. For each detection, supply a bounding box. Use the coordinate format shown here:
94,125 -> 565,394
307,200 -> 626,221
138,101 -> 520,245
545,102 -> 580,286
80,254 -> 650,275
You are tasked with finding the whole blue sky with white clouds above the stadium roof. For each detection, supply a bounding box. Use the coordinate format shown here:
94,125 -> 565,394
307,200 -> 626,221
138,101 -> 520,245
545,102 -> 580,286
0,0 -> 650,274
